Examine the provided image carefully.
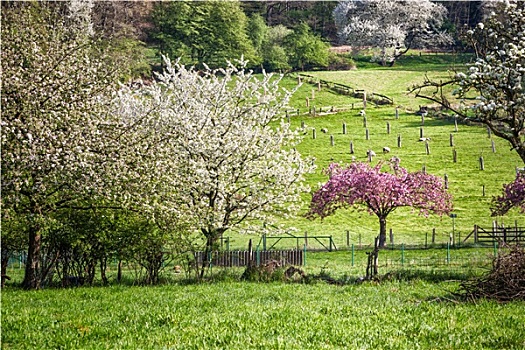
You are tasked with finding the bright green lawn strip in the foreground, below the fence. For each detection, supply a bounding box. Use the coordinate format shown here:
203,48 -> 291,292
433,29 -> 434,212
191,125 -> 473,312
2,280 -> 525,349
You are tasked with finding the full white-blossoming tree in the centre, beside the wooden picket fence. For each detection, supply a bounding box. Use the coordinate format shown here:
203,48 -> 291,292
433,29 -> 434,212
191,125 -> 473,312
117,60 -> 312,278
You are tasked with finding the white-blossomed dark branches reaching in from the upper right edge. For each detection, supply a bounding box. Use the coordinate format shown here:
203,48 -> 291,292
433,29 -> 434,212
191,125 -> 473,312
412,1 -> 525,162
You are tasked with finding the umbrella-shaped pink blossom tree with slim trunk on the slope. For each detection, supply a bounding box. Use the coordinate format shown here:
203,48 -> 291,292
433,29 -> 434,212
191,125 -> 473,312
308,158 -> 452,247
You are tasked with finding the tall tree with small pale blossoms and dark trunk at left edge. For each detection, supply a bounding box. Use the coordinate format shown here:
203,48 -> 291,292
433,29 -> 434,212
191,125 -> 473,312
1,3 -> 116,288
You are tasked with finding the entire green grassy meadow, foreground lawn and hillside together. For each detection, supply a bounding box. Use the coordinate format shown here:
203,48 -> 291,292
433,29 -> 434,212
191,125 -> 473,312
1,55 -> 525,349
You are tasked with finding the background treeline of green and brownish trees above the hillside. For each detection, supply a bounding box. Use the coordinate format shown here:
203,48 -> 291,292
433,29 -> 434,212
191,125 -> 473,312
60,1 -> 483,77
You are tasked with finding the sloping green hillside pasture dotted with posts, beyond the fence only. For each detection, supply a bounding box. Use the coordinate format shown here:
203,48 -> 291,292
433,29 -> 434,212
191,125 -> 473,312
222,60 -> 525,249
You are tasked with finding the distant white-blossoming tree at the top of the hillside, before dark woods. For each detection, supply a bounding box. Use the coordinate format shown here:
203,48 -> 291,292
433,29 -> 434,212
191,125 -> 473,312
334,0 -> 451,65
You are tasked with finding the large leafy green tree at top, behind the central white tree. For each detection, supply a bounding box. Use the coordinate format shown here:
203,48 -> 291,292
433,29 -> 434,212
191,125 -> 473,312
151,1 -> 257,67
